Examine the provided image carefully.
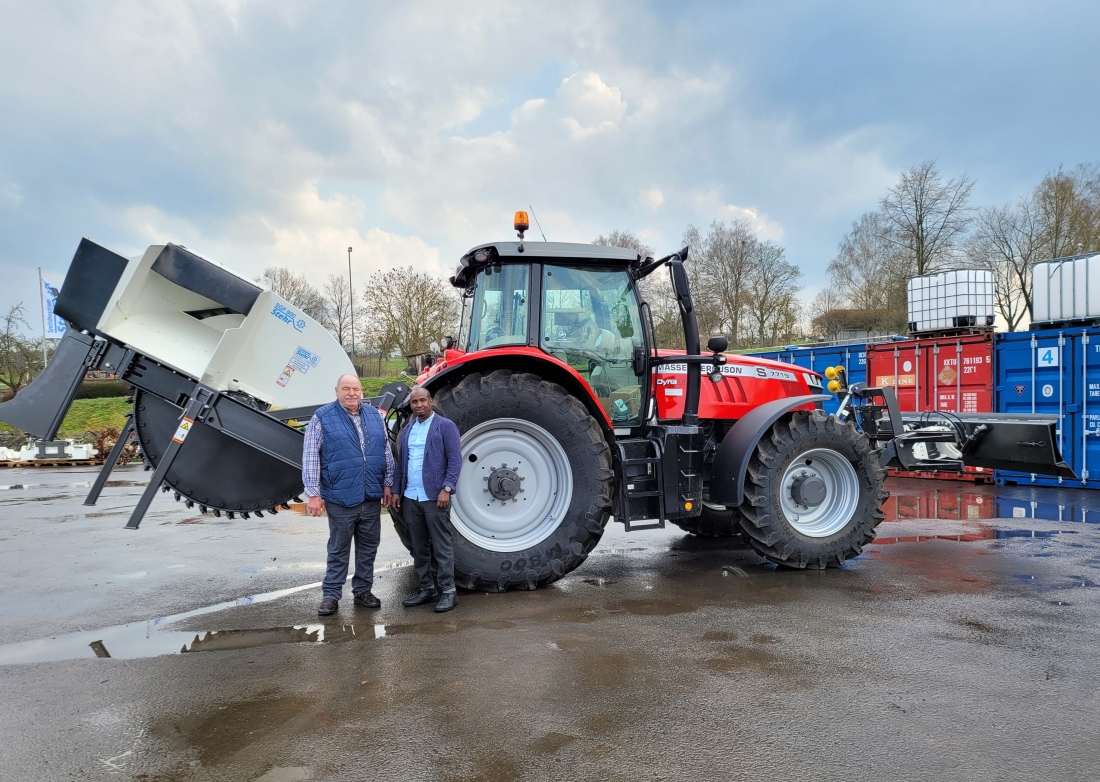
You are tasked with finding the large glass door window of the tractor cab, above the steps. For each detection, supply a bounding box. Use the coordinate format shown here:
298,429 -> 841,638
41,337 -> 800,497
539,266 -> 644,425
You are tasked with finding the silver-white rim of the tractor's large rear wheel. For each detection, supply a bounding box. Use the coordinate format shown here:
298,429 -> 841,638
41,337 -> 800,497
451,418 -> 573,552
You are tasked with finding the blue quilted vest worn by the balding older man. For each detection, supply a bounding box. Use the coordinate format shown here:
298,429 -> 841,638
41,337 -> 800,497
317,400 -> 389,508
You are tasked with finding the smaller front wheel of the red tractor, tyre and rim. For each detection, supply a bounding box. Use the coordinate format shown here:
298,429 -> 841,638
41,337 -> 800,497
737,410 -> 889,569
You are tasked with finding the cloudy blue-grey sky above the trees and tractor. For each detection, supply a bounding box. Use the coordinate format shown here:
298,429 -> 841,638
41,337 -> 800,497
0,0 -> 1100,322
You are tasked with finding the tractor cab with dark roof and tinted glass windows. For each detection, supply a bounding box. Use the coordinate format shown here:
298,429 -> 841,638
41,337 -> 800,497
452,241 -> 649,428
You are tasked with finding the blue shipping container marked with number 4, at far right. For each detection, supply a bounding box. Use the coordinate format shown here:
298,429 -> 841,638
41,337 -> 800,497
993,327 -> 1100,488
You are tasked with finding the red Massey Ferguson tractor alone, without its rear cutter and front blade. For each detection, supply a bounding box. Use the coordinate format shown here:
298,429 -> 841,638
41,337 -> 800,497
391,216 -> 888,592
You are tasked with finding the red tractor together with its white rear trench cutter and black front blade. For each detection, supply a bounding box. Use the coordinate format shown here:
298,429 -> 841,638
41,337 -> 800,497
0,219 -> 1075,592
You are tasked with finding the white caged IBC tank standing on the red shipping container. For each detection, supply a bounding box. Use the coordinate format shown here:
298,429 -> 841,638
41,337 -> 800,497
909,268 -> 994,333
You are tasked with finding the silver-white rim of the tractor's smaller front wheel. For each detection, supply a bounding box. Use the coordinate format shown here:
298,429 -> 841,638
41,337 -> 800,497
779,448 -> 859,538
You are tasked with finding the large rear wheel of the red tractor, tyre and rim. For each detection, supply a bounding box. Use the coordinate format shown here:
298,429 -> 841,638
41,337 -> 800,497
436,370 -> 614,592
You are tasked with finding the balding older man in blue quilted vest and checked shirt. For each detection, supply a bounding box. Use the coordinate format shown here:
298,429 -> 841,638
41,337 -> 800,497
301,375 -> 394,616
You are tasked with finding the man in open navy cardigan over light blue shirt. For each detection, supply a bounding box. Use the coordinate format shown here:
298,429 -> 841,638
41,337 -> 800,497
393,386 -> 462,614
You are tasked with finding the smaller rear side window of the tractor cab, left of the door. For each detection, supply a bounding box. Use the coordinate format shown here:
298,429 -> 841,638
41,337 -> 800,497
462,264 -> 530,351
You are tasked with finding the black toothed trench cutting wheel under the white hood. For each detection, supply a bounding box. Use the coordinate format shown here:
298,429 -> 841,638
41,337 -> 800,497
133,390 -> 301,518
